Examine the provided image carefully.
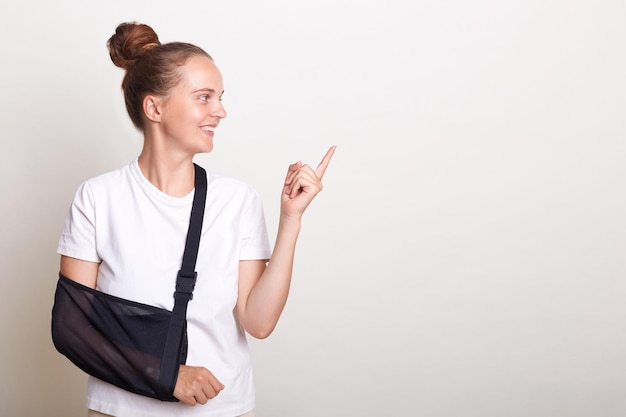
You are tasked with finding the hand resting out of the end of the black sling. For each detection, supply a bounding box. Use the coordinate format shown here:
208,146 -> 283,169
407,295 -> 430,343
174,365 -> 224,405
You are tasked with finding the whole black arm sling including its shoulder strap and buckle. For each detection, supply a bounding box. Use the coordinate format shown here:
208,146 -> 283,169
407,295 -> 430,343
52,164 -> 207,402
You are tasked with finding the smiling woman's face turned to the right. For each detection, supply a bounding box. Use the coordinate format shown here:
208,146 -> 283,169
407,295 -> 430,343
160,56 -> 226,155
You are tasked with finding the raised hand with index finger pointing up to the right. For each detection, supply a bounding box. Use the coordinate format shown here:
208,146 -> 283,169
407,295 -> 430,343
280,146 -> 336,217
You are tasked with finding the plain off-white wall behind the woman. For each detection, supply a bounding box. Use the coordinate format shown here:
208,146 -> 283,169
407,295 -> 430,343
0,0 -> 626,417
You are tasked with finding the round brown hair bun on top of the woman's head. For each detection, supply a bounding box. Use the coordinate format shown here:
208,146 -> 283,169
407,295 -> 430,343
107,22 -> 161,70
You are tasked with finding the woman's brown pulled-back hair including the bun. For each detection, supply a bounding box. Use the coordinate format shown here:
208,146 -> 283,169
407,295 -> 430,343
107,22 -> 212,131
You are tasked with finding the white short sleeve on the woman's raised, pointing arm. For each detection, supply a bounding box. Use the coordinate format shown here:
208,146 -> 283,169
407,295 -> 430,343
239,190 -> 272,261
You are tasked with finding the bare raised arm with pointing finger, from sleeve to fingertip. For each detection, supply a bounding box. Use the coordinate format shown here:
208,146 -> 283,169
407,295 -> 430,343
236,146 -> 335,339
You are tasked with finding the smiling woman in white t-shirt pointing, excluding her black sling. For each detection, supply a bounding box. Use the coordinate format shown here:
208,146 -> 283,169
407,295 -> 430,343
58,23 -> 335,417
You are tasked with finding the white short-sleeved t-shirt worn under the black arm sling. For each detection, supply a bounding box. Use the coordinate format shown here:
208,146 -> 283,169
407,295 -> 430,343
57,159 -> 271,417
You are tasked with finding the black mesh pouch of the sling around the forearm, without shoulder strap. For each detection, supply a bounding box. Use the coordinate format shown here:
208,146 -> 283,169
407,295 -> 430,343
52,274 -> 187,401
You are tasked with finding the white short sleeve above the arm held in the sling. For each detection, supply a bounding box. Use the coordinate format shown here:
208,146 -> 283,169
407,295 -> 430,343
57,183 -> 101,262
